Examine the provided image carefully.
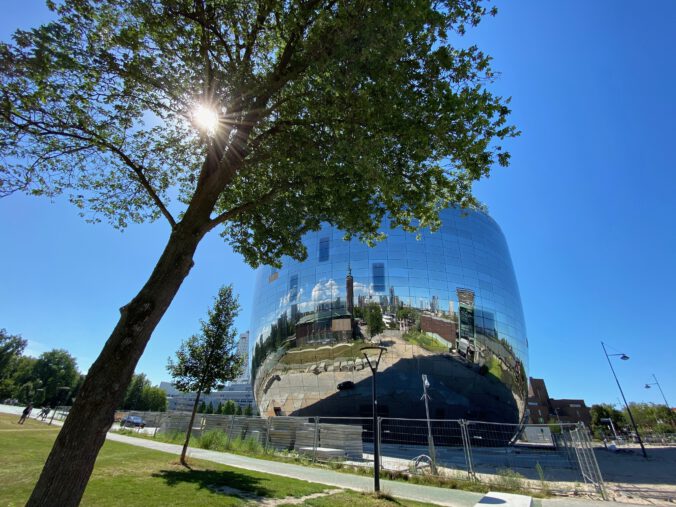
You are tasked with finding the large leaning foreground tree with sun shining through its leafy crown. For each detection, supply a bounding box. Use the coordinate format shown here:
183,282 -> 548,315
0,0 -> 517,505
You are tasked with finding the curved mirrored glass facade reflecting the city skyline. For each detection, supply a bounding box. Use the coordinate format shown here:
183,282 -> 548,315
251,208 -> 528,423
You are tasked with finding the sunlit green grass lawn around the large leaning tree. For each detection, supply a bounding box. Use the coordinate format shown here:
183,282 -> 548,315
0,414 -> 430,507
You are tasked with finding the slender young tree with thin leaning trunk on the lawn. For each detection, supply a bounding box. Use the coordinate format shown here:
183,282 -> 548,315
167,285 -> 242,465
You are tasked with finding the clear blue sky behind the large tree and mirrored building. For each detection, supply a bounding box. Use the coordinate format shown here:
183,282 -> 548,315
0,0 -> 676,404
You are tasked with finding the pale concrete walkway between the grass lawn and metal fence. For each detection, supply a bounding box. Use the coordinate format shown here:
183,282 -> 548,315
0,405 -> 637,507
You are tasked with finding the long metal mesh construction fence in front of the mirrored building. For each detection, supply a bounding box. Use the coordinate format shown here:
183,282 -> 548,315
111,412 -> 606,499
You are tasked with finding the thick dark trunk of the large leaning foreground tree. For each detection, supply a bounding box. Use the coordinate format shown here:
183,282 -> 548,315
27,218 -> 206,507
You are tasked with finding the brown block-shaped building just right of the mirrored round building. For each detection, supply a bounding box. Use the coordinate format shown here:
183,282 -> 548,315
528,377 -> 591,426
